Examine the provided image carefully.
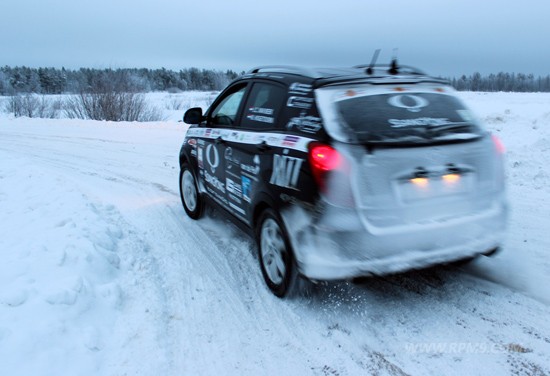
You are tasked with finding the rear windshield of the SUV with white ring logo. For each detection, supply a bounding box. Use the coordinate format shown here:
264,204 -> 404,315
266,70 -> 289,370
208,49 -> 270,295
335,90 -> 481,144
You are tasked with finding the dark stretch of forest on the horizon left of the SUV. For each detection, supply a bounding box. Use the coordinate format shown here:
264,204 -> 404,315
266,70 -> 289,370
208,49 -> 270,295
0,66 -> 242,95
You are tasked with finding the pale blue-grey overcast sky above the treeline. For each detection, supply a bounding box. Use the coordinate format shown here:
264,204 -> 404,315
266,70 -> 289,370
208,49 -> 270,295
0,0 -> 550,76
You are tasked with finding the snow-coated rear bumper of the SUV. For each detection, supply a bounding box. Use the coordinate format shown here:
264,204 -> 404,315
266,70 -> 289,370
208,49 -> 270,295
287,199 -> 507,280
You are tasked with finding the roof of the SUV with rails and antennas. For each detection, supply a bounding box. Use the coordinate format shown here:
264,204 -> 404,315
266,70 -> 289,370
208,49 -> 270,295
239,63 -> 449,88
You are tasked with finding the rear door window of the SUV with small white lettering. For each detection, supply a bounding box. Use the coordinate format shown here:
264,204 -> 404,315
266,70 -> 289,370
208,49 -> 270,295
241,82 -> 287,129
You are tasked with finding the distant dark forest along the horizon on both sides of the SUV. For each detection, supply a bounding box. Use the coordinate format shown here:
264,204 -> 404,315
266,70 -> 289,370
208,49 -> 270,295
0,66 -> 550,95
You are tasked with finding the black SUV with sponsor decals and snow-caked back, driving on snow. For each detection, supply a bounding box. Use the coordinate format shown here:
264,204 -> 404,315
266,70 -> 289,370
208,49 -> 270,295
180,61 -> 506,296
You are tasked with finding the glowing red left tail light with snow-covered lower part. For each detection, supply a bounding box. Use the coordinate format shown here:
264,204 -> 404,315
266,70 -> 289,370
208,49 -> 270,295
309,143 -> 354,207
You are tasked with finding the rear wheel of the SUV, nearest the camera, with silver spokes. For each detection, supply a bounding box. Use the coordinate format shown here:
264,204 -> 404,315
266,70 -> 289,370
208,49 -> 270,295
256,209 -> 302,298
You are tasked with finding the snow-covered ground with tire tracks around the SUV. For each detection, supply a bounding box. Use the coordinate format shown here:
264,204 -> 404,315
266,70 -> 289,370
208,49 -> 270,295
0,93 -> 550,375
